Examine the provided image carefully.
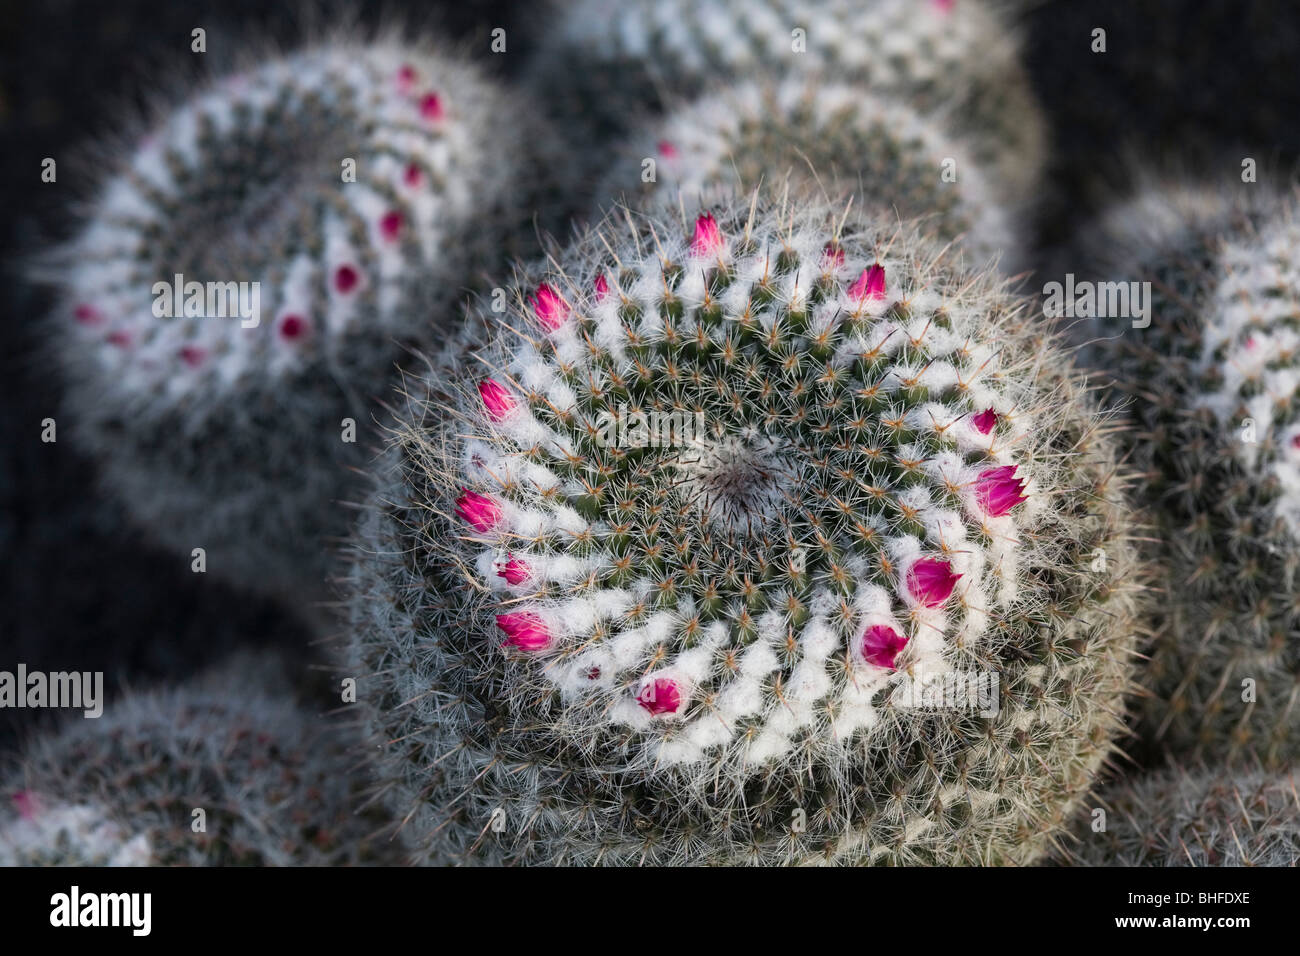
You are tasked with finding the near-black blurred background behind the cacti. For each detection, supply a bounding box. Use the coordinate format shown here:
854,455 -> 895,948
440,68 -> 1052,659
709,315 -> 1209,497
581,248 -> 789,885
0,0 -> 1300,750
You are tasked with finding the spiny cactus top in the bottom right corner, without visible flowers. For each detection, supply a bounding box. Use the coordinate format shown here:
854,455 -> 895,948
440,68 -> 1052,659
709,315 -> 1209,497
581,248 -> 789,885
1073,767 -> 1300,866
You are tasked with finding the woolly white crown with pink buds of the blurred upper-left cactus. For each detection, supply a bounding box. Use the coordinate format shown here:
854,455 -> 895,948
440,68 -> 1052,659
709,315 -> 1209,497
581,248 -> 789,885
50,43 -> 525,410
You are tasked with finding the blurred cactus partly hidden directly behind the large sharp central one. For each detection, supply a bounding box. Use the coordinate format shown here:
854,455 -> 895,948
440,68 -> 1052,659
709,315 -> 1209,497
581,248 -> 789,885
597,81 -> 1017,269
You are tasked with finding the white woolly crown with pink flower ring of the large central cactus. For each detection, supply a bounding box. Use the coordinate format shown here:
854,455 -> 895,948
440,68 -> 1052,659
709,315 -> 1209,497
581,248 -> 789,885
444,195 -> 1052,763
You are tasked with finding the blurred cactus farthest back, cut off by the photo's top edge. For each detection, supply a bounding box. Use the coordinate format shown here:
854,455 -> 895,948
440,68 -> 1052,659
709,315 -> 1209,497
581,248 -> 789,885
530,0 -> 1047,209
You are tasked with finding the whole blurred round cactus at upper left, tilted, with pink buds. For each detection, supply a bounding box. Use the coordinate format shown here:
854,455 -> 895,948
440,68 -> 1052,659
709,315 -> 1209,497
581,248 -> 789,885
39,40 -> 554,605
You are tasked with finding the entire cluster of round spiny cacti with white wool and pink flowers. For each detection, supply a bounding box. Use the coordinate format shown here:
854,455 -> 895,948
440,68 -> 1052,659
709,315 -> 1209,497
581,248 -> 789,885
17,0 -> 1300,865
